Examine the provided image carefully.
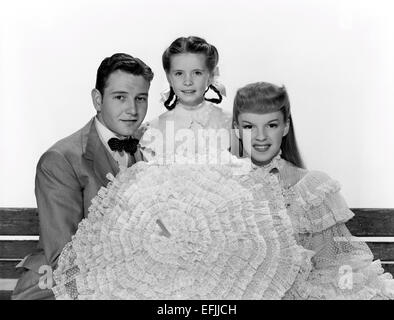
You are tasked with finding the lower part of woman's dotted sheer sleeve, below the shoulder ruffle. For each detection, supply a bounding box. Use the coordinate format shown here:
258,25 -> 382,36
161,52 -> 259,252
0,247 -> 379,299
286,223 -> 394,300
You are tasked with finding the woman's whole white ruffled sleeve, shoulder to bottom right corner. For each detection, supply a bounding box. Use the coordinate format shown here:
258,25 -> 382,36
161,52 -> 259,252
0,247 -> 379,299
284,172 -> 394,300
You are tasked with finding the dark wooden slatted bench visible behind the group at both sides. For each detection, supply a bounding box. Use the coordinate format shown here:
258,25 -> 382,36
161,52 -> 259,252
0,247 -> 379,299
0,208 -> 394,300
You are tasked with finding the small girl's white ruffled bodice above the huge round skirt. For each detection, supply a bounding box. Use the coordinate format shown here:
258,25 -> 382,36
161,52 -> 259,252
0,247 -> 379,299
140,101 -> 233,163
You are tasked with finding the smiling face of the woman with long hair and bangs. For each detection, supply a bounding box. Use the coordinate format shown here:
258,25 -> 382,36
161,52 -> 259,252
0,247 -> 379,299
238,111 -> 289,166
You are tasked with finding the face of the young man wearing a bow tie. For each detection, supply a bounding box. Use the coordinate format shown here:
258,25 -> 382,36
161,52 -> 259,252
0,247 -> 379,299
92,70 -> 150,137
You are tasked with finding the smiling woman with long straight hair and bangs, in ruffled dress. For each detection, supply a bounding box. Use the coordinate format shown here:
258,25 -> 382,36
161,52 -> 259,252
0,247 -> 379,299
233,82 -> 394,299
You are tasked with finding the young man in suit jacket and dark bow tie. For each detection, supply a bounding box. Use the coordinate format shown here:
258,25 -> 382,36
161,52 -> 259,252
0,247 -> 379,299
12,53 -> 153,299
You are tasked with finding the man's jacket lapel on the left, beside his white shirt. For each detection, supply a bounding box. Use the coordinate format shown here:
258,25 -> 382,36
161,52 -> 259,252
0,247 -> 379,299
82,118 -> 119,186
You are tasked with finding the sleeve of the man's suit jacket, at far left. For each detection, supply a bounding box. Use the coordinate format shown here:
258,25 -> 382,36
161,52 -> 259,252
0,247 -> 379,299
35,150 -> 83,266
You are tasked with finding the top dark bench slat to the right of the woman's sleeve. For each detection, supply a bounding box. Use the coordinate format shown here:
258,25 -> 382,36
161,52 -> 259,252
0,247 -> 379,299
346,208 -> 394,237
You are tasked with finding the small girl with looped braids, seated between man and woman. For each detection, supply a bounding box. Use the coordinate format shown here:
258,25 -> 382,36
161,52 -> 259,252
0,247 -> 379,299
140,37 -> 231,164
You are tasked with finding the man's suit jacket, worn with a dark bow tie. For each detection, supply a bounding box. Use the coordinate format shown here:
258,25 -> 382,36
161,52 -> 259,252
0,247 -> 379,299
12,118 -> 142,299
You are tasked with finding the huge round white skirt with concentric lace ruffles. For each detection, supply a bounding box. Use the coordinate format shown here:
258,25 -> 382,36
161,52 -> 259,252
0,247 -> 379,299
53,162 -> 311,299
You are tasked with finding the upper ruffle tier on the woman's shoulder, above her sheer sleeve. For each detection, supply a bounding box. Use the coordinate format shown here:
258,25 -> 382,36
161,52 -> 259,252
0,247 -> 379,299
292,171 -> 354,233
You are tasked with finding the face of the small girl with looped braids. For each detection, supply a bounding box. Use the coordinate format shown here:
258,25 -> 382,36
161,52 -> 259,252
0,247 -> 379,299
167,53 -> 212,107
